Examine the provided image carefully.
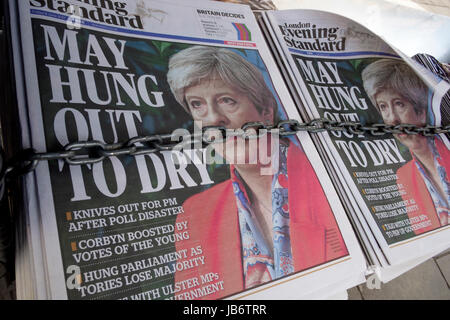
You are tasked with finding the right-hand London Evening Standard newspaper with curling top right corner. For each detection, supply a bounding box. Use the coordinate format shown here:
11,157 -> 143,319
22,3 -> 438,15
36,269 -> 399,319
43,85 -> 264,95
264,10 -> 450,267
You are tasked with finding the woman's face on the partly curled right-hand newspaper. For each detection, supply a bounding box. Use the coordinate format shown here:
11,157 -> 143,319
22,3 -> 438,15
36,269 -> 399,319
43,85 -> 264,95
375,89 -> 426,152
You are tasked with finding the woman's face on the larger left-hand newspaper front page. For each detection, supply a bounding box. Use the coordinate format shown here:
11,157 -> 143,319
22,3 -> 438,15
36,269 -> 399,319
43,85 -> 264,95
185,77 -> 274,163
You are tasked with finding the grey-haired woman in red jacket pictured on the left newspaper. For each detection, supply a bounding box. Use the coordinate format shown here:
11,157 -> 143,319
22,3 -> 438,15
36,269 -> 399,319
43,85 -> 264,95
167,46 -> 348,299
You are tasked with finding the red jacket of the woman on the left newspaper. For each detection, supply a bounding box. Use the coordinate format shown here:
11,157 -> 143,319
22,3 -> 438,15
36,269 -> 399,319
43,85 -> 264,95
175,146 -> 348,299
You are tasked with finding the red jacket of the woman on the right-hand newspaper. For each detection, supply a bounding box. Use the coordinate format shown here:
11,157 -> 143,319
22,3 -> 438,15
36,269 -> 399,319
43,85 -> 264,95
397,138 -> 450,234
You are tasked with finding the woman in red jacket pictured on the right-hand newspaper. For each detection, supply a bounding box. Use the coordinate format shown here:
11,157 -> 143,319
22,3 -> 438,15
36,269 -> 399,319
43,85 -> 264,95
362,59 -> 450,234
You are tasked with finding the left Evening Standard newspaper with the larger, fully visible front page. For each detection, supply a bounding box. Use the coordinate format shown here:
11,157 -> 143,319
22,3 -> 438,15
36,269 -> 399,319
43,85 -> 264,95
10,0 -> 366,300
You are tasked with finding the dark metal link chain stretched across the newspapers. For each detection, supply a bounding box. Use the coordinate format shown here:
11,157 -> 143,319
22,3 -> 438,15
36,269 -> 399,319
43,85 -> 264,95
0,119 -> 450,182
